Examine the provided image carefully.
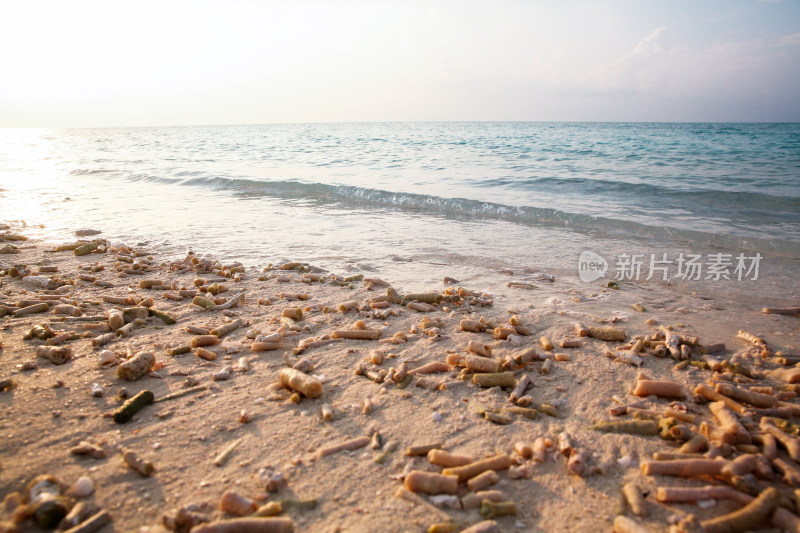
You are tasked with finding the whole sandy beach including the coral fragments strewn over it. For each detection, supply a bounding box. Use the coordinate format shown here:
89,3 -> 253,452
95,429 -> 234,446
0,221 -> 800,533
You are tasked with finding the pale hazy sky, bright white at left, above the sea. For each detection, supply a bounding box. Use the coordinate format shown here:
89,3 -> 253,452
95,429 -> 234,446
0,0 -> 800,127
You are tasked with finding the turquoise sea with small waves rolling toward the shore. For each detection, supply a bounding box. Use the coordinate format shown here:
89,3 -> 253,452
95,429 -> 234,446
0,122 -> 800,299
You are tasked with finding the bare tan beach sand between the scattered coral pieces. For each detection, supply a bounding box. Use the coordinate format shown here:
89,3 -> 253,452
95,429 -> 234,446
0,221 -> 800,532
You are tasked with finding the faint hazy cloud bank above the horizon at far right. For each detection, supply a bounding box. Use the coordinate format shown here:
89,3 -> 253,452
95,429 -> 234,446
572,22 -> 800,121
